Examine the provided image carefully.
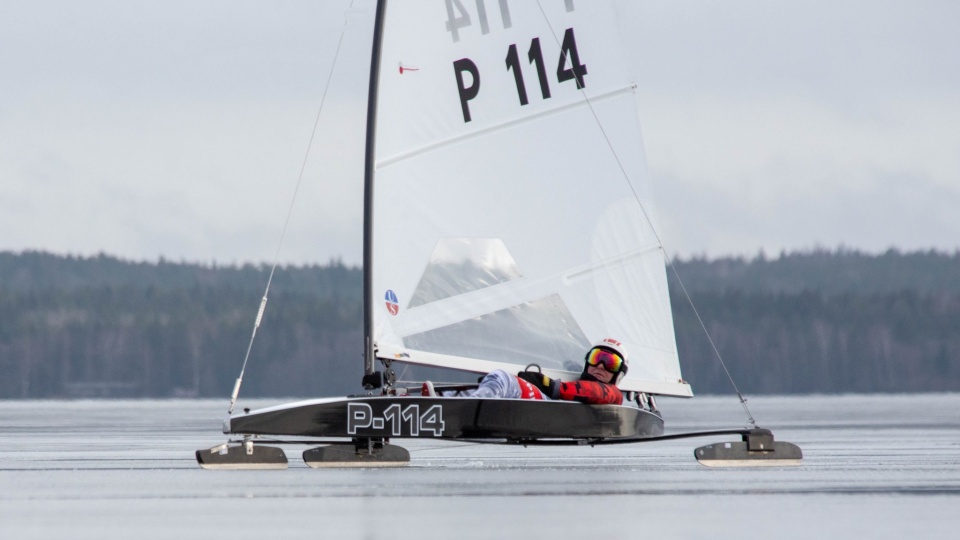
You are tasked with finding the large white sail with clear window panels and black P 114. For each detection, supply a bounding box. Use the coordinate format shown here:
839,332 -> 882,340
372,0 -> 691,396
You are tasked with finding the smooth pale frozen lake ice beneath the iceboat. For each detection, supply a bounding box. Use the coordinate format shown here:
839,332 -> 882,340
0,394 -> 960,540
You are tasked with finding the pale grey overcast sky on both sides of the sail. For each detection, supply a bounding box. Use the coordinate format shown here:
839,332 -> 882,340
0,0 -> 960,263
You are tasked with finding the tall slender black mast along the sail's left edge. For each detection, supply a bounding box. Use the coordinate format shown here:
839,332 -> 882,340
363,0 -> 387,388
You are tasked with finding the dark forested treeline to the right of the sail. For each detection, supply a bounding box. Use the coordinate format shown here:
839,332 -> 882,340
668,250 -> 960,393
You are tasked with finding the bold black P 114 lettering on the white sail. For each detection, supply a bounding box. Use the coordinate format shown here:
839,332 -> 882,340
453,28 -> 587,122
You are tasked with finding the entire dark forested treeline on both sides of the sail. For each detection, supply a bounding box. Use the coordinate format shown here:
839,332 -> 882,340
0,250 -> 960,398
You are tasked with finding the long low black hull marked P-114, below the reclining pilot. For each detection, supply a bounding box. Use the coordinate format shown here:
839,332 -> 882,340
224,396 -> 663,440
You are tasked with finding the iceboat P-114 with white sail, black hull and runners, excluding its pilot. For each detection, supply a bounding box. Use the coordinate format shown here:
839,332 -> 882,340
197,0 -> 804,468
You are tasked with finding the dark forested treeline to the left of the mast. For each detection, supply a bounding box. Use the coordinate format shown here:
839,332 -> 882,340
0,252 -> 362,398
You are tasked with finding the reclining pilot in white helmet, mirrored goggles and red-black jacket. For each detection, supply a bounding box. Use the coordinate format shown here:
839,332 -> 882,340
421,338 -> 628,405
